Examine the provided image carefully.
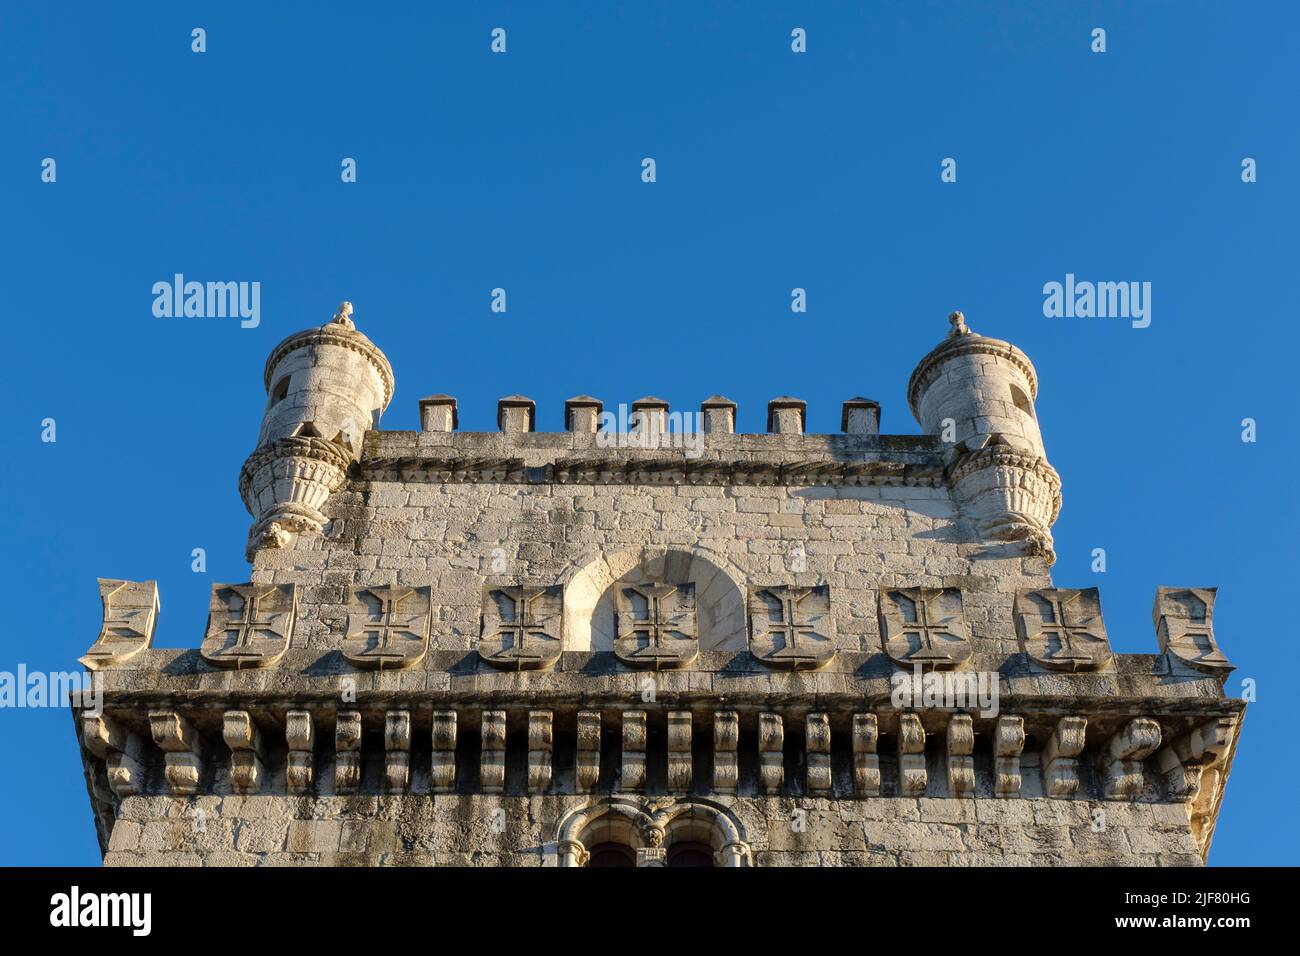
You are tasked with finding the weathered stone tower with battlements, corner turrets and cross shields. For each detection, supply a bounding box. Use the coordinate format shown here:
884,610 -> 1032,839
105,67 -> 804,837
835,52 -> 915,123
74,303 -> 1244,866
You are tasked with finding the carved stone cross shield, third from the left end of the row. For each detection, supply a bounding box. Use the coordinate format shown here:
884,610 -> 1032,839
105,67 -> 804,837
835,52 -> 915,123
343,587 -> 433,670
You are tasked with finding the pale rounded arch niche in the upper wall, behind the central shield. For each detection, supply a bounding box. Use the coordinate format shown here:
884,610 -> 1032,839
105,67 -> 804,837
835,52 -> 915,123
563,548 -> 748,650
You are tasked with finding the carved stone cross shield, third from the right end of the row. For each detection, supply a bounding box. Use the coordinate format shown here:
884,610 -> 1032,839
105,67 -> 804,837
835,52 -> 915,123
879,588 -> 972,669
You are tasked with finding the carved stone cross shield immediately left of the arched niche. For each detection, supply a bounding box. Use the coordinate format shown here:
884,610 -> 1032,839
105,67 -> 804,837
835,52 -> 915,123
478,585 -> 564,671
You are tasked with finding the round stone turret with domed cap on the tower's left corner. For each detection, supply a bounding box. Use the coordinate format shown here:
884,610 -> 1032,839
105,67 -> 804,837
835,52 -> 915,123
239,302 -> 394,561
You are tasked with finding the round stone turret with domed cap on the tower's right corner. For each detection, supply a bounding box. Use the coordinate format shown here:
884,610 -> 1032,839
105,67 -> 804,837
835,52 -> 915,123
907,312 -> 1061,559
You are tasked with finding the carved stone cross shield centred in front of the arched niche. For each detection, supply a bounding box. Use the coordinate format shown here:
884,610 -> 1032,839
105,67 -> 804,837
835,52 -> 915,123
614,583 -> 699,670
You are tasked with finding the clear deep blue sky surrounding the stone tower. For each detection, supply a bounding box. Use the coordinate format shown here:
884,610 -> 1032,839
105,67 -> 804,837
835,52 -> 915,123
0,1 -> 1300,864
